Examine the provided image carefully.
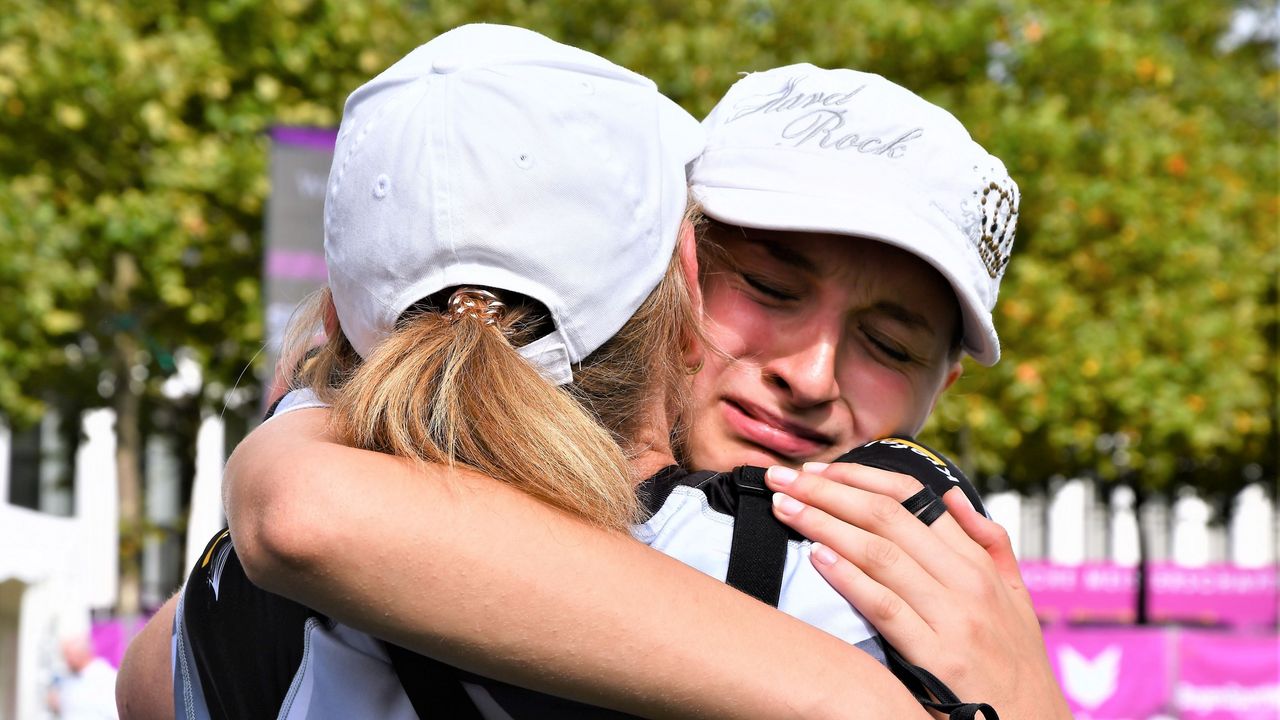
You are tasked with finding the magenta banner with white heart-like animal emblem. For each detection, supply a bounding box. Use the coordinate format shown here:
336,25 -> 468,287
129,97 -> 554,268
1039,628 -> 1171,720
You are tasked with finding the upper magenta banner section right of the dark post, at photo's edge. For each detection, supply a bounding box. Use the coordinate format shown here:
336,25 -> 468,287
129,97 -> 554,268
1148,562 -> 1280,625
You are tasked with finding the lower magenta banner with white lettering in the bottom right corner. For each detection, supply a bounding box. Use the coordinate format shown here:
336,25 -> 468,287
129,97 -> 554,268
1174,630 -> 1280,720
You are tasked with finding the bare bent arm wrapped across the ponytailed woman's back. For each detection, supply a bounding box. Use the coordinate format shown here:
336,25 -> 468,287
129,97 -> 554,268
225,410 -> 927,717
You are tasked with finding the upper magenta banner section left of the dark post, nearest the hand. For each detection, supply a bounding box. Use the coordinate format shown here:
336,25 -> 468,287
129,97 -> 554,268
1020,561 -> 1138,623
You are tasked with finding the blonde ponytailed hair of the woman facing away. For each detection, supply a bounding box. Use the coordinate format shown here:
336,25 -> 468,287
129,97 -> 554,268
280,221 -> 703,530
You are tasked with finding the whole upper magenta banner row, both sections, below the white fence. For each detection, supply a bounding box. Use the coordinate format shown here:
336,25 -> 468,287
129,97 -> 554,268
1021,561 -> 1280,628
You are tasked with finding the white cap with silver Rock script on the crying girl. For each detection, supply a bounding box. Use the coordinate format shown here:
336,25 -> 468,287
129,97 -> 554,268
690,64 -> 1019,365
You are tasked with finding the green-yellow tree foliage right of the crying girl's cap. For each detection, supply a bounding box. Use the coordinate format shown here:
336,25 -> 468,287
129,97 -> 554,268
921,3 -> 1280,495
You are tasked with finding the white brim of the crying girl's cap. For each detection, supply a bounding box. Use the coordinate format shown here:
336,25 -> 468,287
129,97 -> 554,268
691,184 -> 1000,365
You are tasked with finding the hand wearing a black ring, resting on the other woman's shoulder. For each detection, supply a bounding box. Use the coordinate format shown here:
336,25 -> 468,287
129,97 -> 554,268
767,464 -> 1070,719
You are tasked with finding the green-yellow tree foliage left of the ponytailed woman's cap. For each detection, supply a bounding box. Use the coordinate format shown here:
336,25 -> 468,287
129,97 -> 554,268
0,0 -> 430,423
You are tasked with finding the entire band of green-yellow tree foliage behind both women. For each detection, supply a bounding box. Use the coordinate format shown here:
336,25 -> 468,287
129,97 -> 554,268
0,0 -> 1280,492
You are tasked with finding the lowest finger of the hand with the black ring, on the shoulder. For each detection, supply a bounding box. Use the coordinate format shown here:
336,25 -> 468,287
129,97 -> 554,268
809,543 -> 937,648
